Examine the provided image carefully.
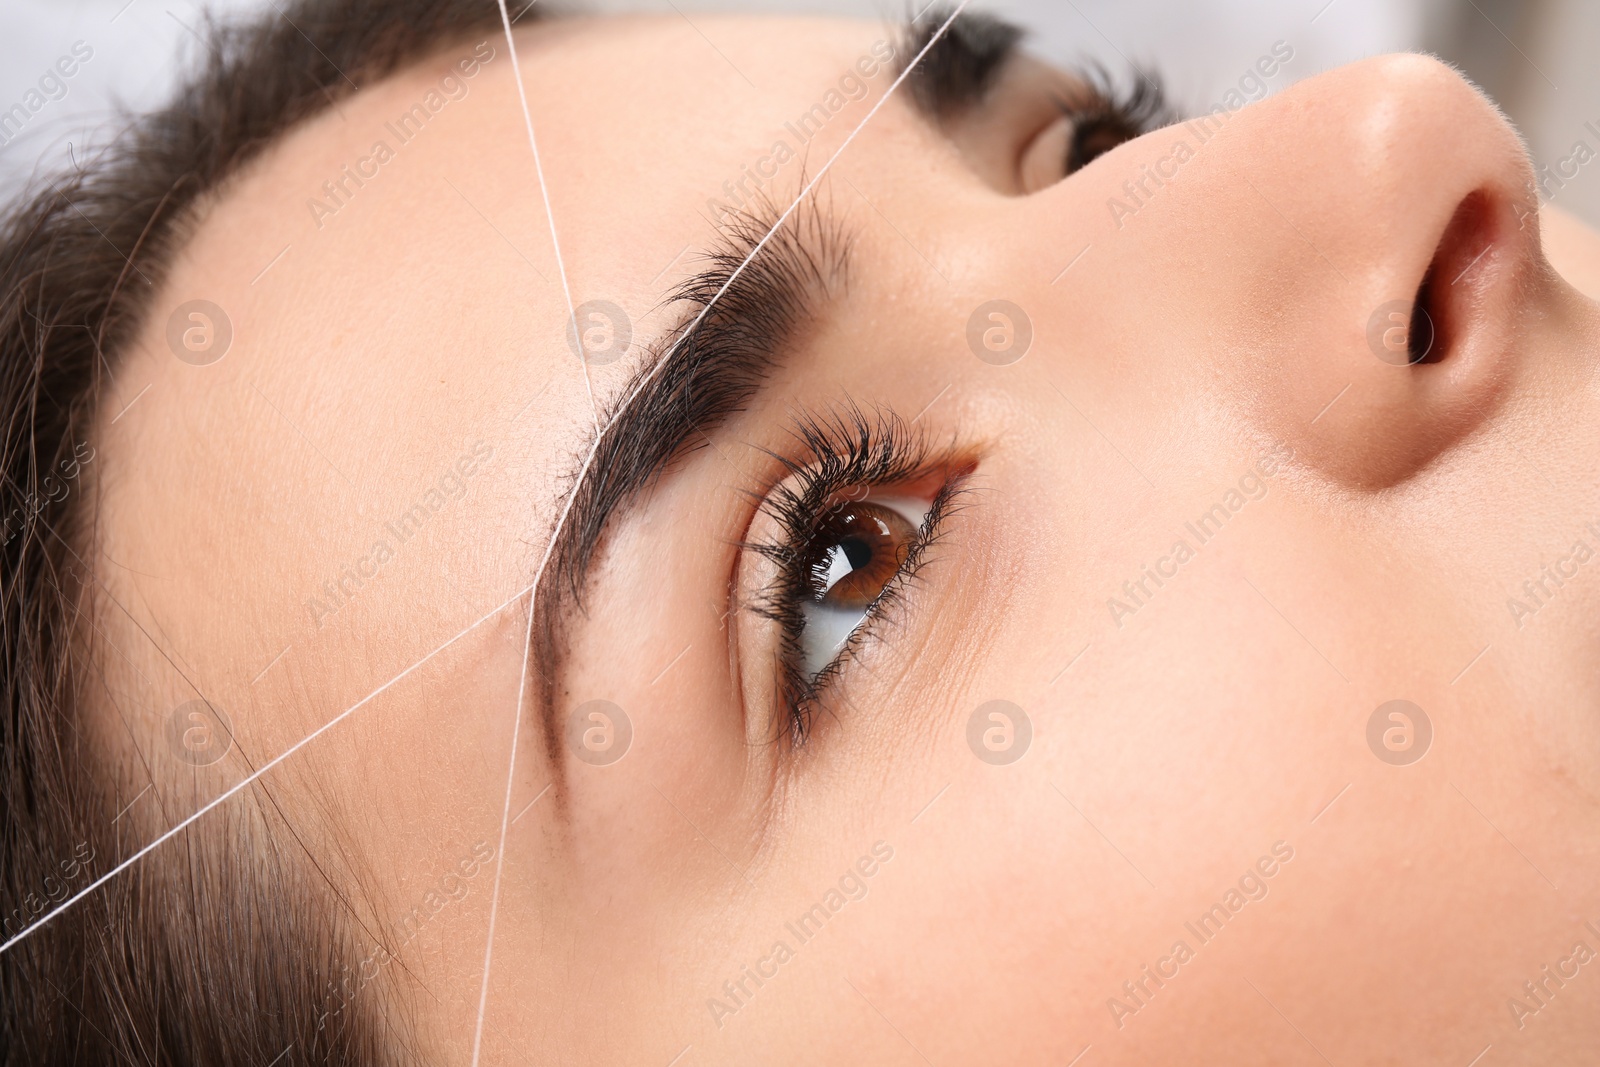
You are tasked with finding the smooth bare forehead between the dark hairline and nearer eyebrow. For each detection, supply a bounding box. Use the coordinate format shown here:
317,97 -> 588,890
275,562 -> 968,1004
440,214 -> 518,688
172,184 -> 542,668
90,10 -> 914,751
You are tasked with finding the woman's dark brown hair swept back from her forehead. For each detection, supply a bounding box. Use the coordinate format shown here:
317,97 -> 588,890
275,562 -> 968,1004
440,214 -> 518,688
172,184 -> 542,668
0,0 -> 531,1067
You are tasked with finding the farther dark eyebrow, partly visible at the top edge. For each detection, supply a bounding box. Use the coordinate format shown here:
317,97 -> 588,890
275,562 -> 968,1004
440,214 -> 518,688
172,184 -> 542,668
901,3 -> 1026,123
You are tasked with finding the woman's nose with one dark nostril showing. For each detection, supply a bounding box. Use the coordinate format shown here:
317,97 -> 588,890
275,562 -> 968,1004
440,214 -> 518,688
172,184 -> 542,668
1043,54 -> 1542,488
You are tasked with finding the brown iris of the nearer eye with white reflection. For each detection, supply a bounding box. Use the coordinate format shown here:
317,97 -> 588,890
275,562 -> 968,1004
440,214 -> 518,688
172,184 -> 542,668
811,501 -> 917,611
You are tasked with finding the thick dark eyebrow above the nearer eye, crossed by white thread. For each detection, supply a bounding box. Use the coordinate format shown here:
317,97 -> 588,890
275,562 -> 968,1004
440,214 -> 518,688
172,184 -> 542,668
533,191 -> 851,735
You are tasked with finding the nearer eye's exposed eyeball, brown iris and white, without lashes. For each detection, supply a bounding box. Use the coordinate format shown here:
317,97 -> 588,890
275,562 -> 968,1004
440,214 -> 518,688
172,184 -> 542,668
800,499 -> 928,677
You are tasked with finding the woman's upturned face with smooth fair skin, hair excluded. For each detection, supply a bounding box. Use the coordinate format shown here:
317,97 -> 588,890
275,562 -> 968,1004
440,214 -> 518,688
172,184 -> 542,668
94,16 -> 1600,1064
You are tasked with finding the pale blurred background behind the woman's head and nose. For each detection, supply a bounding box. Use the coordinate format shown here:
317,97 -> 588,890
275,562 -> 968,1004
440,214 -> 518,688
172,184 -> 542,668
0,0 -> 1600,226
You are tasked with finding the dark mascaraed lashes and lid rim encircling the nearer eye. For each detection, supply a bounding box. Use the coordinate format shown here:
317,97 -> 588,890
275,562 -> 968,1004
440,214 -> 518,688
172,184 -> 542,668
741,406 -> 960,744
